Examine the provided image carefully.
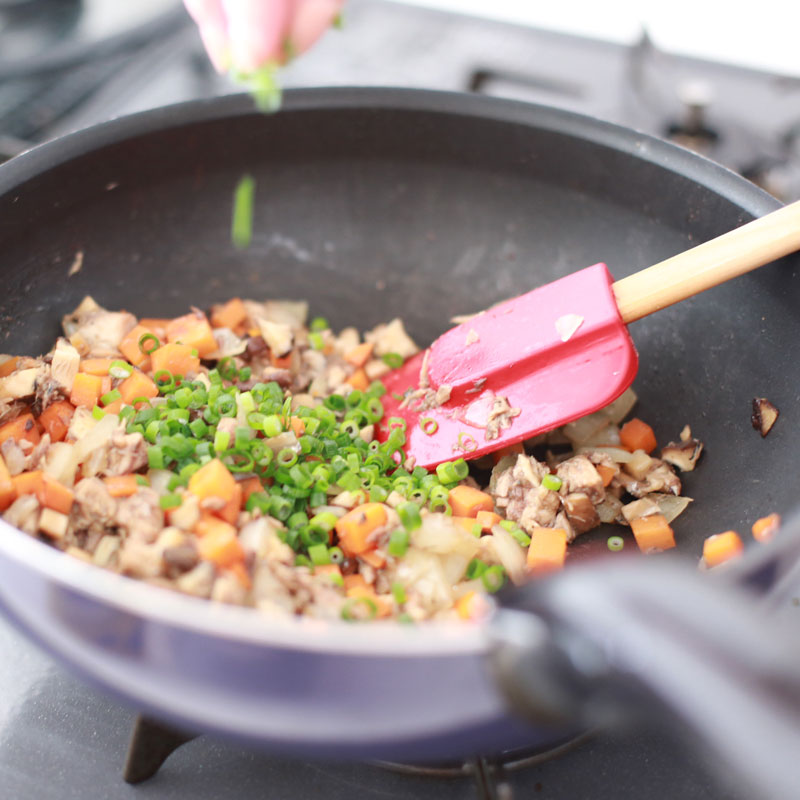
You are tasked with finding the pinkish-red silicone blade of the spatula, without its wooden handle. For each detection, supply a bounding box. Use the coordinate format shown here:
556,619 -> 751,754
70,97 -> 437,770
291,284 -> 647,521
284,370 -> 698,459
378,264 -> 638,467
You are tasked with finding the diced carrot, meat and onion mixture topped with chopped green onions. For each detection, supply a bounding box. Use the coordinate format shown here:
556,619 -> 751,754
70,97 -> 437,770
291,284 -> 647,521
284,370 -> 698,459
0,297 -> 702,622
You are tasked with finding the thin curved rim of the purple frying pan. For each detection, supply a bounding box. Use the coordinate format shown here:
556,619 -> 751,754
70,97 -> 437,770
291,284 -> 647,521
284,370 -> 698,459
0,87 -> 781,658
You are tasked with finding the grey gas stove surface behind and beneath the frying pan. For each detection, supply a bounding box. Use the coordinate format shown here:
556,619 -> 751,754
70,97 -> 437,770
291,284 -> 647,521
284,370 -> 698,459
0,0 -> 800,800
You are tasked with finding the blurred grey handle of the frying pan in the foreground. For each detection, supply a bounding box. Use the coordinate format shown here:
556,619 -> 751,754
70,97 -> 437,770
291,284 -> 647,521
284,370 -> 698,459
490,544 -> 800,800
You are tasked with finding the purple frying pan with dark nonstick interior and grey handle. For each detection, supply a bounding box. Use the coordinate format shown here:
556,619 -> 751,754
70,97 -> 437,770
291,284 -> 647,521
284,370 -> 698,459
0,89 -> 800,796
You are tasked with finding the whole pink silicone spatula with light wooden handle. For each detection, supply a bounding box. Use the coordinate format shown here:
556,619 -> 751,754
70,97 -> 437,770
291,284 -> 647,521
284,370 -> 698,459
378,201 -> 800,467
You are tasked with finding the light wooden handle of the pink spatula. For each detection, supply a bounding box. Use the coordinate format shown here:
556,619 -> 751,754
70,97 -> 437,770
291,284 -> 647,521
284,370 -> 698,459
612,201 -> 800,323
